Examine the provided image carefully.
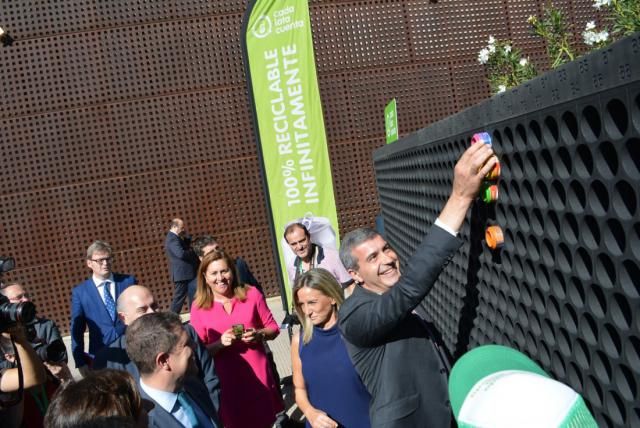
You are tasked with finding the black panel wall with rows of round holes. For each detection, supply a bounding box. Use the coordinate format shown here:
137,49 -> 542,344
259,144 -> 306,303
374,33 -> 640,427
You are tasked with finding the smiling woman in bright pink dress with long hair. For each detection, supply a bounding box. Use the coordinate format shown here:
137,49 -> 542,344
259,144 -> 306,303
191,251 -> 284,428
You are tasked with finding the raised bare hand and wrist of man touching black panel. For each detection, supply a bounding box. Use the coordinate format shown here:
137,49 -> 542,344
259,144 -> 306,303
438,143 -> 498,232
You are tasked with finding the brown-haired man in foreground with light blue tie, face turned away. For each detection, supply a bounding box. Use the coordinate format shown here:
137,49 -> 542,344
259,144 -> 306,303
126,312 -> 221,428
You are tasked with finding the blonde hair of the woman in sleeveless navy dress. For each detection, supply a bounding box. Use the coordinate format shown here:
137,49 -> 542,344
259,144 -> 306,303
293,268 -> 344,345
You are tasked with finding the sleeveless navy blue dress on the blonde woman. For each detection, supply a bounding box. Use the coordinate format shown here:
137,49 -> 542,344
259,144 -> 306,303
299,323 -> 371,428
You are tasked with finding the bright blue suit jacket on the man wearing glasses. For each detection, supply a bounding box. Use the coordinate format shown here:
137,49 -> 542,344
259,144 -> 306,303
71,273 -> 137,367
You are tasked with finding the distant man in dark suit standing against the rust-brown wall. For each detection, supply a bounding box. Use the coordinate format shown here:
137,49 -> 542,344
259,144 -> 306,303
164,218 -> 198,314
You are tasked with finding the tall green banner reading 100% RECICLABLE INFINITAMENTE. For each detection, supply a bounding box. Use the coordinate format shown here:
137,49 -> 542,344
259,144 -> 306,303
243,0 -> 338,308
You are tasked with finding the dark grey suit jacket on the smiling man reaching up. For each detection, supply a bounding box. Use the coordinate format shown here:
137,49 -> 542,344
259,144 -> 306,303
339,226 -> 462,428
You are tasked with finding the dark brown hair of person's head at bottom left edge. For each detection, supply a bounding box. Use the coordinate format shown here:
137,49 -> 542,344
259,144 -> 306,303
44,369 -> 142,428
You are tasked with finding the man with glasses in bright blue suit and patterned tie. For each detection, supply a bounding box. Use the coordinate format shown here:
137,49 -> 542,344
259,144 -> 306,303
71,241 -> 137,375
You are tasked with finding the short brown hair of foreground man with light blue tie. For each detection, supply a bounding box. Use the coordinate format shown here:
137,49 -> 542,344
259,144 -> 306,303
126,312 -> 182,375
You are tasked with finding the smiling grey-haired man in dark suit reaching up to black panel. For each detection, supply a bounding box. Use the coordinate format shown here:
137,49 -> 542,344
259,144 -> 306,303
339,144 -> 496,428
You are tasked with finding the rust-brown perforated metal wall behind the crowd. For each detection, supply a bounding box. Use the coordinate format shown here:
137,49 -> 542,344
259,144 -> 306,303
0,0 -> 593,331
